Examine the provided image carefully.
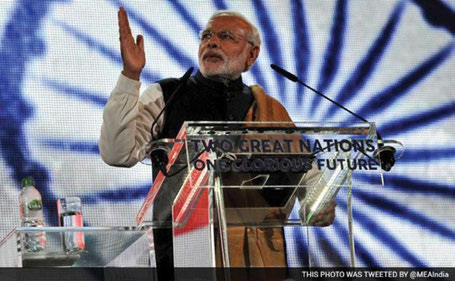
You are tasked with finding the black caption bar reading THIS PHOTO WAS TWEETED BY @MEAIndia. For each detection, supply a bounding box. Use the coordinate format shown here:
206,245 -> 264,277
0,267 -> 455,281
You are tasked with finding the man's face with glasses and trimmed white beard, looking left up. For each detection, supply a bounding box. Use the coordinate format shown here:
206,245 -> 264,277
198,16 -> 259,81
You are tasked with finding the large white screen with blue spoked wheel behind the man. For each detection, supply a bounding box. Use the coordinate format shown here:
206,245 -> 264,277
0,0 -> 455,266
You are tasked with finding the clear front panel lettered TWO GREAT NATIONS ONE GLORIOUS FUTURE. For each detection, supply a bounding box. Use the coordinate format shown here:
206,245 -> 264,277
183,122 -> 382,185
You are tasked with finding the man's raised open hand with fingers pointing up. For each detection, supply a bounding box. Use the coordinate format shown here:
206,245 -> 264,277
118,7 -> 145,80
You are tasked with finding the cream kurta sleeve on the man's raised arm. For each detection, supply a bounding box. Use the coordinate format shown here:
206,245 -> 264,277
98,74 -> 164,167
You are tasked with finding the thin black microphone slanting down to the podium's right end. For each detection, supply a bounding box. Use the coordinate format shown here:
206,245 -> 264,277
270,64 -> 397,172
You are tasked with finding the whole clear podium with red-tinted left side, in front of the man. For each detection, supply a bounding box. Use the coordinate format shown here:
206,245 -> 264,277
137,122 -> 383,267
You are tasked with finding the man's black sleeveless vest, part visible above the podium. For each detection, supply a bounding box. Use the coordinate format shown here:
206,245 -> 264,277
158,71 -> 254,138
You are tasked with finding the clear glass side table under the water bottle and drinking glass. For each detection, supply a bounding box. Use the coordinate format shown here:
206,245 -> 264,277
0,227 -> 153,267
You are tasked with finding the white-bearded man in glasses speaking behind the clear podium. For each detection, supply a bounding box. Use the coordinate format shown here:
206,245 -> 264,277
99,8 -> 335,276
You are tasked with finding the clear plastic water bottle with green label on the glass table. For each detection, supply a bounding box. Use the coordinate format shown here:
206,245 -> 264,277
19,177 -> 46,252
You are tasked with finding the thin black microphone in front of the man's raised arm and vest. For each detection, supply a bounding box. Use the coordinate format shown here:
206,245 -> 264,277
149,67 -> 194,177
